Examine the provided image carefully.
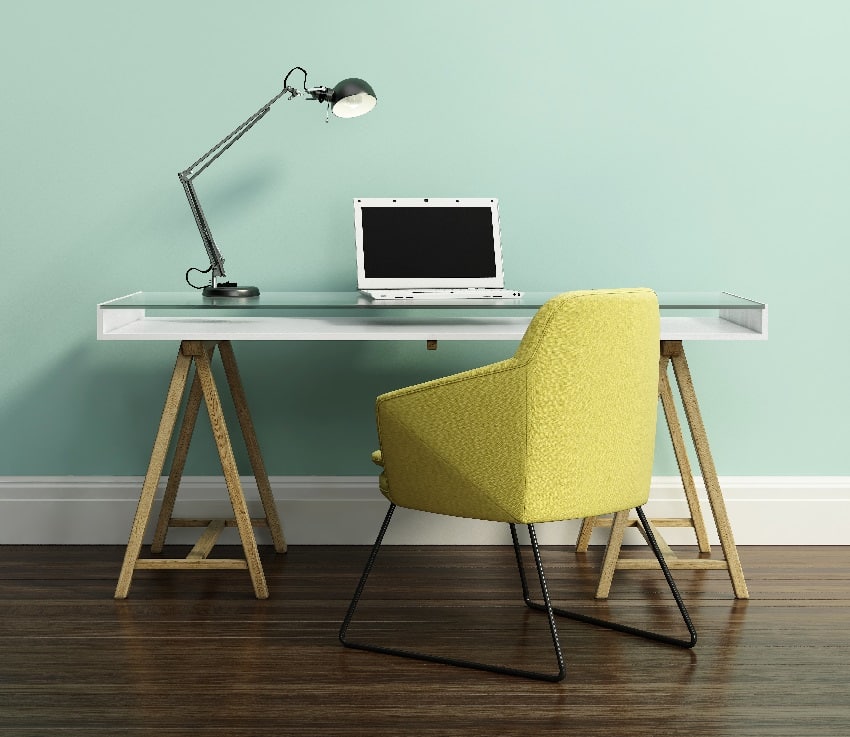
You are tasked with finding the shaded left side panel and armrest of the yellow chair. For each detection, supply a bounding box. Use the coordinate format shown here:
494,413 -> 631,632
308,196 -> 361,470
376,358 -> 526,521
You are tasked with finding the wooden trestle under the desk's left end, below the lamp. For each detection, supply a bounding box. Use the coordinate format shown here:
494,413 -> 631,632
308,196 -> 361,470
115,340 -> 286,599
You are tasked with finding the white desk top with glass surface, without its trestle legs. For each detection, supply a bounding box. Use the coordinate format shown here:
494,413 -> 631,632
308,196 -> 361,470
97,292 -> 767,341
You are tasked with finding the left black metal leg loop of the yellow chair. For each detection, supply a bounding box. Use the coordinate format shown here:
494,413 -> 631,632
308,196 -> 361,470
339,504 -> 565,682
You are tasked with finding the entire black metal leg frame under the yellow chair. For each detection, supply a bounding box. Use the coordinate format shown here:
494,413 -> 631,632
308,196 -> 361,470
339,504 -> 697,682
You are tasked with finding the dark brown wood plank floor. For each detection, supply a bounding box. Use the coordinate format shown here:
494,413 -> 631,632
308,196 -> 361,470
0,546 -> 850,737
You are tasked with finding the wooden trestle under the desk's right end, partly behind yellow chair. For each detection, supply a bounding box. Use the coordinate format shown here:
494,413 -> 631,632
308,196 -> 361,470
576,340 -> 749,599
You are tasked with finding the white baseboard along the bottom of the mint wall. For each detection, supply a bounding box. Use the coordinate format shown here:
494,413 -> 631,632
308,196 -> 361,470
0,476 -> 850,545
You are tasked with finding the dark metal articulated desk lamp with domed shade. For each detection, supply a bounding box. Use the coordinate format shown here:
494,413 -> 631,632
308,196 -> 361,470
177,67 -> 378,297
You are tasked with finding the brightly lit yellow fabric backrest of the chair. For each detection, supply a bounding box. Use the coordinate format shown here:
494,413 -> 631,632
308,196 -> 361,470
506,289 -> 660,521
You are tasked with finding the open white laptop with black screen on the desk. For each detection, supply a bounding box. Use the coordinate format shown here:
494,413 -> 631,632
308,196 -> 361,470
354,197 -> 522,300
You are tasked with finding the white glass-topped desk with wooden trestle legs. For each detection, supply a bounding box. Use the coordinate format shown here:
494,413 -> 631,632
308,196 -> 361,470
97,292 -> 767,598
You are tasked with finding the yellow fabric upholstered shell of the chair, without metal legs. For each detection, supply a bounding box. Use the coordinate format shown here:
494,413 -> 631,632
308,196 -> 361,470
372,289 -> 660,524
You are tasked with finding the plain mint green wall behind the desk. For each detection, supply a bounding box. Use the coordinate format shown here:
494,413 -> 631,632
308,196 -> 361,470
0,0 -> 850,475
